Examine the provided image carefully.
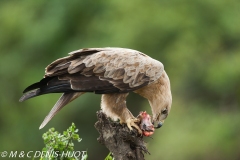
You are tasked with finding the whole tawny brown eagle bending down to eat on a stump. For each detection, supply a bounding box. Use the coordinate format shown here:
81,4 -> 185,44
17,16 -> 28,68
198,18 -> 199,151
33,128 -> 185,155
20,48 -> 172,132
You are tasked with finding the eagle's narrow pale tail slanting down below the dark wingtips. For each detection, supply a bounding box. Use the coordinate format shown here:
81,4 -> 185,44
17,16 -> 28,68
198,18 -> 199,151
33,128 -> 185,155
39,92 -> 84,129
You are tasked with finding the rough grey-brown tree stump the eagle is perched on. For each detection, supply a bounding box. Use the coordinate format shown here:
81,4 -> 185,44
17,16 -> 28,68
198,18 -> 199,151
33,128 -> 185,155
95,111 -> 149,160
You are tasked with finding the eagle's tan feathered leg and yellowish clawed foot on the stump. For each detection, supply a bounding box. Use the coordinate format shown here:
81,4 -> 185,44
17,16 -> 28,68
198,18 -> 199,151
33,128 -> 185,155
101,93 -> 142,134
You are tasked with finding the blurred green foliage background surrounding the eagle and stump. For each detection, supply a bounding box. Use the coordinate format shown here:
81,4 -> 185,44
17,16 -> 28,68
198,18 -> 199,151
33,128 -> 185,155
0,0 -> 240,160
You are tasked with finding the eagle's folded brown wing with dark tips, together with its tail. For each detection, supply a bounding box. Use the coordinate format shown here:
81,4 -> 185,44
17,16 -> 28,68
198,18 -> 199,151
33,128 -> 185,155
20,48 -> 164,128
